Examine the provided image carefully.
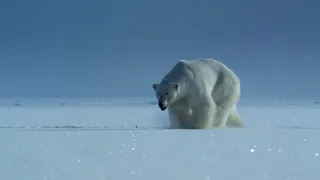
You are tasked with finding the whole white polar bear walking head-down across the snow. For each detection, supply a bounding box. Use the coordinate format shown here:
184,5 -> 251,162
152,58 -> 243,129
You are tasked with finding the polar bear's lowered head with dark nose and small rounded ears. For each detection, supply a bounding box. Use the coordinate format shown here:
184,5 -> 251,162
152,82 -> 180,111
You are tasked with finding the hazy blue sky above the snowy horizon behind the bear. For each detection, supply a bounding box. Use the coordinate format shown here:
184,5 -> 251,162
0,0 -> 320,98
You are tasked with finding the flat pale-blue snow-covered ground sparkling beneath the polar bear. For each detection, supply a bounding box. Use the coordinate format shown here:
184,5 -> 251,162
0,99 -> 320,180
